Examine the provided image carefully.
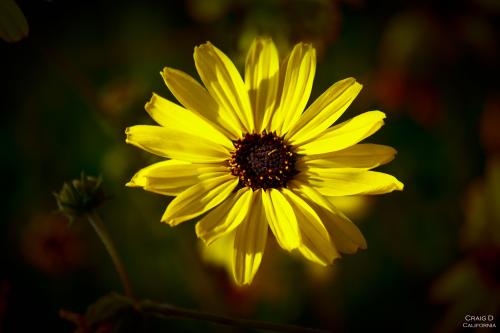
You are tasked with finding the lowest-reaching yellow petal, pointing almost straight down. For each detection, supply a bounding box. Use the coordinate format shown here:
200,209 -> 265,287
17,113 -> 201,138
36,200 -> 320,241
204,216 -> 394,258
232,190 -> 268,285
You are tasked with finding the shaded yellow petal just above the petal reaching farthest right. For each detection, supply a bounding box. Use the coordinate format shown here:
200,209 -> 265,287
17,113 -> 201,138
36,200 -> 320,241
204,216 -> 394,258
303,143 -> 396,169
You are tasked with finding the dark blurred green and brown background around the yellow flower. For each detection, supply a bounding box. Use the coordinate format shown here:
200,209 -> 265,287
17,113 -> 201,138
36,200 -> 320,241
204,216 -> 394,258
0,0 -> 500,332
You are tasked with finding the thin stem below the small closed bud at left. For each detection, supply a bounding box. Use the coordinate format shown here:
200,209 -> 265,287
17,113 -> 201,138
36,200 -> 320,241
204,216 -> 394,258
87,211 -> 134,299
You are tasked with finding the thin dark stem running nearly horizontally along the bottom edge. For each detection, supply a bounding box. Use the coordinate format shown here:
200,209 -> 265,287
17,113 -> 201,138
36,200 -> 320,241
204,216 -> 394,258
137,300 -> 329,333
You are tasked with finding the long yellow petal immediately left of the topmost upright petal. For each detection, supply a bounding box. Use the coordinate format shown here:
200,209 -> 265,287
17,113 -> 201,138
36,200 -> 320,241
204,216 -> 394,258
194,43 -> 254,133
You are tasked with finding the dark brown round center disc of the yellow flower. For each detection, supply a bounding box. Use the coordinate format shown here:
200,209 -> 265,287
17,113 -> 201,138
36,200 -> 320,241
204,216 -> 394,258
228,130 -> 298,190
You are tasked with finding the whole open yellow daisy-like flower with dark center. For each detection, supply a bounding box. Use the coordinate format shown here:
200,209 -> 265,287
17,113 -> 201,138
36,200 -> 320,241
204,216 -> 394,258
126,38 -> 403,284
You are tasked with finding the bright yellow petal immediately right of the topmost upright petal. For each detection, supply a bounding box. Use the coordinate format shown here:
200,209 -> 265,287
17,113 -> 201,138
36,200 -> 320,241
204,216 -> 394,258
271,43 -> 316,135
